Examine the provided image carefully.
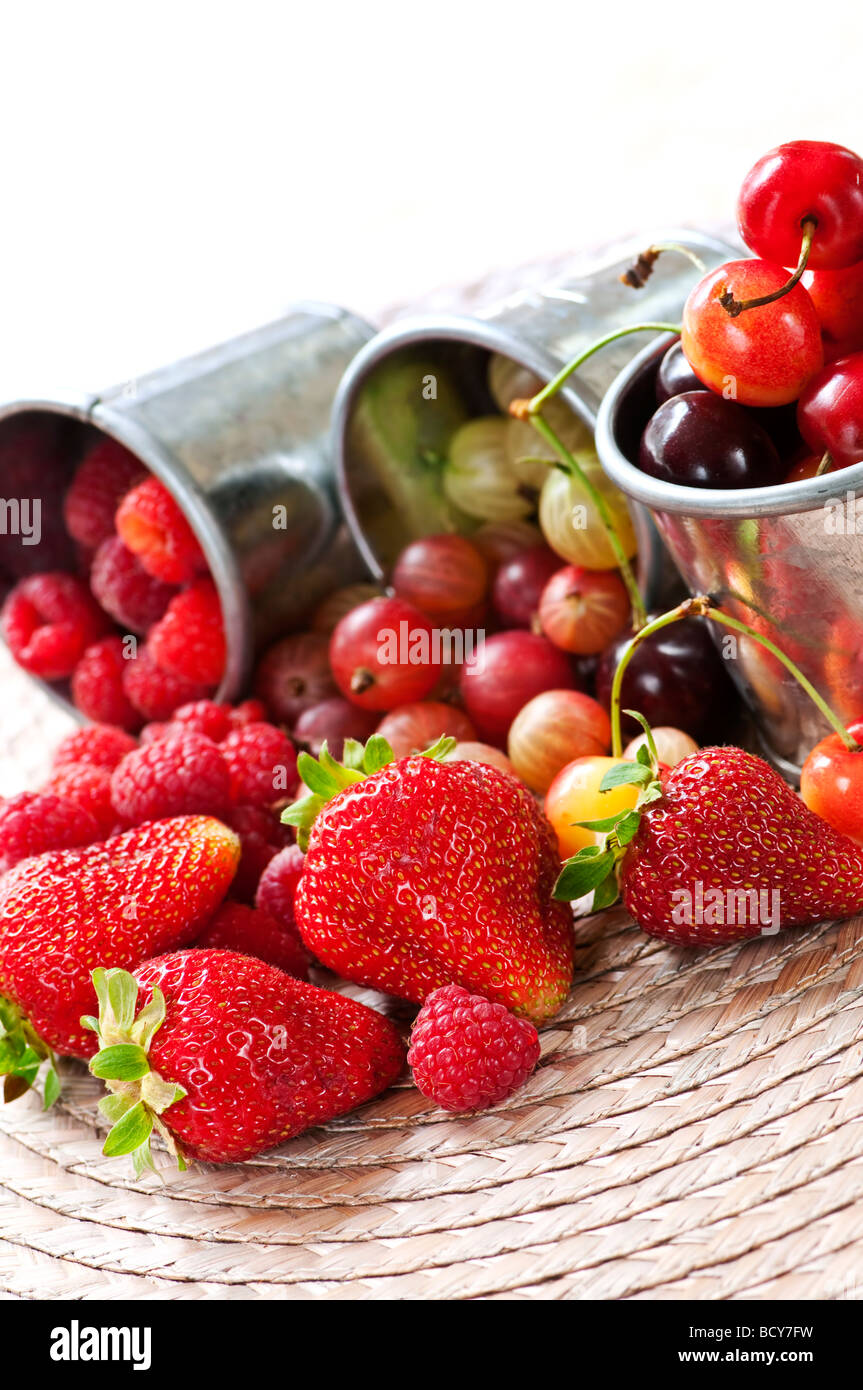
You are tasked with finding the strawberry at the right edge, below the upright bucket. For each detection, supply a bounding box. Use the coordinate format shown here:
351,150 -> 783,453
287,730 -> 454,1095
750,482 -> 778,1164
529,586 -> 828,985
554,748 -> 863,945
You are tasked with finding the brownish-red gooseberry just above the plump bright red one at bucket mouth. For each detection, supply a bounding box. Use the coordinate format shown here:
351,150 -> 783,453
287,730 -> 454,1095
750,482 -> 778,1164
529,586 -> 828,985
392,535 -> 489,624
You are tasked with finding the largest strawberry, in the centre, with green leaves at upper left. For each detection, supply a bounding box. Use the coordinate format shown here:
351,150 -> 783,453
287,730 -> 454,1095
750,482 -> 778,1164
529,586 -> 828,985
283,735 -> 574,1019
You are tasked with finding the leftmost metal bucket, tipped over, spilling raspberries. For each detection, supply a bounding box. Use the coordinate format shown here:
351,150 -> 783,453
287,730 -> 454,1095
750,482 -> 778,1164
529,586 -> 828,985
0,303 -> 374,703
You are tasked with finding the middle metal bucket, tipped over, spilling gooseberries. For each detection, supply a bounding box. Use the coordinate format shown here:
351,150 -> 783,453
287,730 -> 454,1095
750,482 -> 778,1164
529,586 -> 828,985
334,231 -> 735,602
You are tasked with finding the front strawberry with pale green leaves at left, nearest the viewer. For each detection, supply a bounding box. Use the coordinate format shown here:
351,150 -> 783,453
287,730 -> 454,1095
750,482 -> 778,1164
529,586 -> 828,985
89,951 -> 404,1172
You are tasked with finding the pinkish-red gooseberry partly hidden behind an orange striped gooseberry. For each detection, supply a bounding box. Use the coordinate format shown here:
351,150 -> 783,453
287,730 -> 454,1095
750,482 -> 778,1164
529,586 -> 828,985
460,628 -> 575,744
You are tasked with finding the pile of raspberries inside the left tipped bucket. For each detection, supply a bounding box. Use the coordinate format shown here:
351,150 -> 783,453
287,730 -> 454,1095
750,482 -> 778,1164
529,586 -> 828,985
0,439 -> 225,733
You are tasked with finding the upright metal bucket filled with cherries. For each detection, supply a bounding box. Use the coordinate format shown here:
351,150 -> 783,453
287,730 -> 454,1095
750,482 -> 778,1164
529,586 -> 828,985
596,336 -> 863,778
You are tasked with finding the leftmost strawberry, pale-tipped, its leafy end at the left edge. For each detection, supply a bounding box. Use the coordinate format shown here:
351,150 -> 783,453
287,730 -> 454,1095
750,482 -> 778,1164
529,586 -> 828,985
0,816 -> 239,1095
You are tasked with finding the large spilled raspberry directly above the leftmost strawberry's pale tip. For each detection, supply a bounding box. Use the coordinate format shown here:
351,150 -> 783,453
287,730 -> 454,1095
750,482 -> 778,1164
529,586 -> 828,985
111,734 -> 231,826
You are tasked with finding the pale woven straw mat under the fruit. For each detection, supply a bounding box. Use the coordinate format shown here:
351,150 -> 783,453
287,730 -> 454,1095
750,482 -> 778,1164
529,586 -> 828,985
0,255 -> 863,1300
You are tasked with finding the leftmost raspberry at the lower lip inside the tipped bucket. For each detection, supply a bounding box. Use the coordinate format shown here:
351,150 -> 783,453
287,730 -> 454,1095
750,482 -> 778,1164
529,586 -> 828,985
1,571 -> 108,681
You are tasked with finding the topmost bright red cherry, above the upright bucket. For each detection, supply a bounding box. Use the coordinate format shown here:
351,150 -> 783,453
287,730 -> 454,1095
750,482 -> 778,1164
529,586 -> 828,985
737,140 -> 863,270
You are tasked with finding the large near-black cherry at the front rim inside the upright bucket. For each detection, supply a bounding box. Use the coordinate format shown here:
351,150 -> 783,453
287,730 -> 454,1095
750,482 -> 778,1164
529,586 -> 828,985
638,391 -> 788,488
